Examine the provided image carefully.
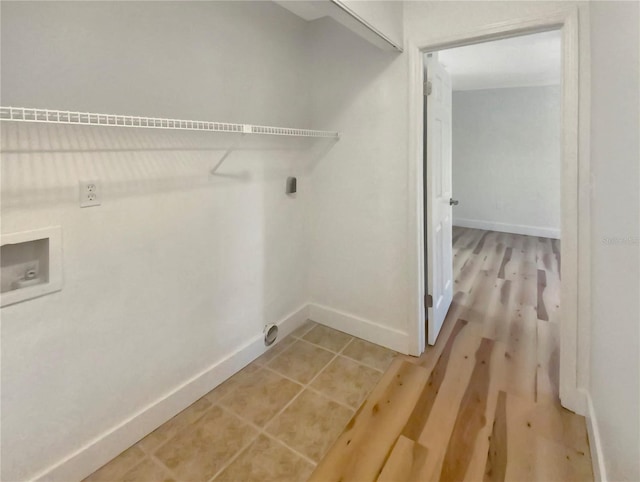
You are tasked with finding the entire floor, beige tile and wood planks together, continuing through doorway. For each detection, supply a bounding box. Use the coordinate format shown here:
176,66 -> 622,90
86,227 -> 593,482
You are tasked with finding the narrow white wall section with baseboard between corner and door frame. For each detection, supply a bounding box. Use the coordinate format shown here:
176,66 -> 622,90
309,18 -> 408,351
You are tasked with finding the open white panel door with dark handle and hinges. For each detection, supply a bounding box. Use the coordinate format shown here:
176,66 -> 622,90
424,54 -> 454,345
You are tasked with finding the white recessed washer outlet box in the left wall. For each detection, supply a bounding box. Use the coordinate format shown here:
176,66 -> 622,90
0,226 -> 62,306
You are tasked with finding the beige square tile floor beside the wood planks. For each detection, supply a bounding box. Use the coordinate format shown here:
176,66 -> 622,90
85,321 -> 395,482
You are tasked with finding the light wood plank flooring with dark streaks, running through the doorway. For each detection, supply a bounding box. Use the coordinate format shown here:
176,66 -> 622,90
310,228 -> 593,482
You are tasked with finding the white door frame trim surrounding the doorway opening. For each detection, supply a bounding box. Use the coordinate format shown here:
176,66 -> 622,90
405,6 -> 591,415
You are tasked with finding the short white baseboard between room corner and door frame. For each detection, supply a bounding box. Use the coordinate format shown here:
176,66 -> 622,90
309,303 -> 409,353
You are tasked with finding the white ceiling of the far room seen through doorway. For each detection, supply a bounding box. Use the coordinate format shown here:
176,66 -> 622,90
438,30 -> 561,90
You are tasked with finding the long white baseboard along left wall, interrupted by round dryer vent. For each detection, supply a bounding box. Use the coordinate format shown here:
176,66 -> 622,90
33,305 -> 309,482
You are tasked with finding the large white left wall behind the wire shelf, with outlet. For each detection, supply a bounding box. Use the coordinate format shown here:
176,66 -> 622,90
1,2 -> 316,481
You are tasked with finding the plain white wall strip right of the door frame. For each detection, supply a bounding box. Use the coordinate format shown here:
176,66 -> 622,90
590,2 -> 640,481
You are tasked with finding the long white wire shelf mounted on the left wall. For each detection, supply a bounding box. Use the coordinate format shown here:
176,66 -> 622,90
0,107 -> 340,139
